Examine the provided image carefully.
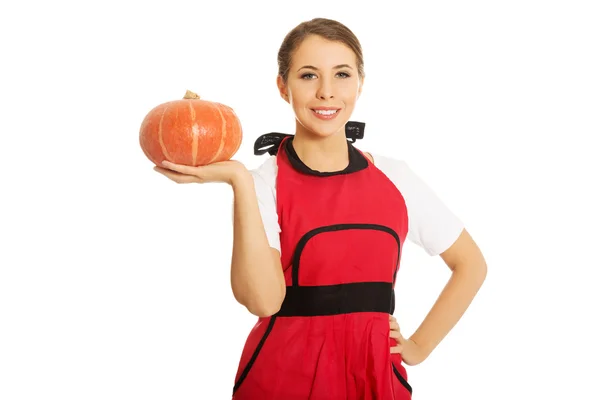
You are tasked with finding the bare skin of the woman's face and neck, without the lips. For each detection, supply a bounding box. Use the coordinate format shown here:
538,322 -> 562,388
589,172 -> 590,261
277,35 -> 364,172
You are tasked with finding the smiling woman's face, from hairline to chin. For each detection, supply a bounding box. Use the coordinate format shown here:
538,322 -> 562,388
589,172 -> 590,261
277,35 -> 362,141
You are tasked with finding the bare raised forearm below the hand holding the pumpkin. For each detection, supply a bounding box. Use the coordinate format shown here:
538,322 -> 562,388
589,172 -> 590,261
231,171 -> 285,317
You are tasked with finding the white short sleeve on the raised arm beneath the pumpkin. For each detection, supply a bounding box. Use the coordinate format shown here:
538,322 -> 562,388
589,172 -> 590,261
233,157 -> 281,252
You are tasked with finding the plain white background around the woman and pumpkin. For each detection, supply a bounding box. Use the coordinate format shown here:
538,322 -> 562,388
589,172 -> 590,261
0,0 -> 600,400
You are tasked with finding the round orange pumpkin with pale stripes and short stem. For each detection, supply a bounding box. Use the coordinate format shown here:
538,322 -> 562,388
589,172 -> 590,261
140,90 -> 242,167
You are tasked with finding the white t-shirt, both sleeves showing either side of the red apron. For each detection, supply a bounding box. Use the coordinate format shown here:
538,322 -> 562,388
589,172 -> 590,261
250,154 -> 464,256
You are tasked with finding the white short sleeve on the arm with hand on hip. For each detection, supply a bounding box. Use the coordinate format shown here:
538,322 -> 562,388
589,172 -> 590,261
373,155 -> 464,256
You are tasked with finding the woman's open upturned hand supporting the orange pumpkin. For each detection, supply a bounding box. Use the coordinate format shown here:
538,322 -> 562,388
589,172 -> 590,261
154,160 -> 249,185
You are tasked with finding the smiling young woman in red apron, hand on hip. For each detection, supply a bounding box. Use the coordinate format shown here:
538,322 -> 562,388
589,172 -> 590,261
156,18 -> 487,400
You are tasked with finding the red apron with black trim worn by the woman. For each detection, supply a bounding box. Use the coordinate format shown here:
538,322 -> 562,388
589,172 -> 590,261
233,135 -> 412,400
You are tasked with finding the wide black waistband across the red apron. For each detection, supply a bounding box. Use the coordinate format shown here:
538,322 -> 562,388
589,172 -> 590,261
276,282 -> 394,317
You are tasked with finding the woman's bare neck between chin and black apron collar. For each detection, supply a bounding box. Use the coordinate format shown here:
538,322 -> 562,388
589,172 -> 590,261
292,123 -> 350,172
